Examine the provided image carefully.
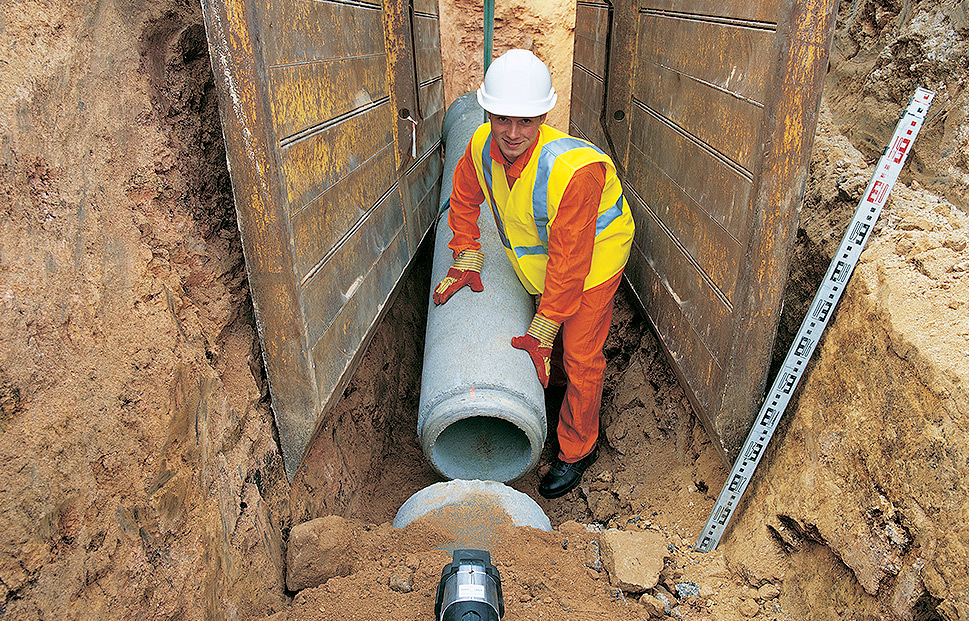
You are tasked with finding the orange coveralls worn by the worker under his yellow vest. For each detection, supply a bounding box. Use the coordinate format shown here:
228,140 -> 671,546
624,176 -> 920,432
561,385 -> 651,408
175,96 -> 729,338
448,132 -> 622,463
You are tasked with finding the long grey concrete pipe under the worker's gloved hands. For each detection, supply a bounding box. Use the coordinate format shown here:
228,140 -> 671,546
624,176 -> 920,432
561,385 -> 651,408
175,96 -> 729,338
417,93 -> 547,482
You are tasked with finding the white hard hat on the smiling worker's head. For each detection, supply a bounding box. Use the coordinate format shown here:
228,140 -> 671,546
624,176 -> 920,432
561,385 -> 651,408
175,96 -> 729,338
478,50 -> 558,117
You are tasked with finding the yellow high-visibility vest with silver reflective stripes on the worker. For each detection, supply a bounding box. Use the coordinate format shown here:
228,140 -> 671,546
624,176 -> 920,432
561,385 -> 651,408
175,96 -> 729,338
471,123 -> 635,294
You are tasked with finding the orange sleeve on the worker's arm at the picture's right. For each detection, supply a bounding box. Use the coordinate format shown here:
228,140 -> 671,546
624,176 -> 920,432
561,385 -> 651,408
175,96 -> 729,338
538,162 -> 606,323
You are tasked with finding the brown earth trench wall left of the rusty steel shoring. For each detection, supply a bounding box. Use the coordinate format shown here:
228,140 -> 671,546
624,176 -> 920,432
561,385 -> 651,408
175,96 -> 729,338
0,1 -> 288,619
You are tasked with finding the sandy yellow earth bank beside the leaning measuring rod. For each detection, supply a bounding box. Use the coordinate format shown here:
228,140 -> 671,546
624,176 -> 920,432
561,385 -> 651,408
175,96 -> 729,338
721,116 -> 969,619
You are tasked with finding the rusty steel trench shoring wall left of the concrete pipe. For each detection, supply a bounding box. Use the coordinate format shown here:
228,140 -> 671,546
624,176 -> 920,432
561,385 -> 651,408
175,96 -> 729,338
208,0 -> 443,477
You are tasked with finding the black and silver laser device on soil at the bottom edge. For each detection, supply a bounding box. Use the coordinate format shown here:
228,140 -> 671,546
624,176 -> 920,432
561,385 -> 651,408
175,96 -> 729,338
434,550 -> 505,621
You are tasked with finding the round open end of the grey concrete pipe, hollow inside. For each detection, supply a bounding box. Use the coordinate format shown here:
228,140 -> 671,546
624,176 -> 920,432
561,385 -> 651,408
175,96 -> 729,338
432,416 -> 533,481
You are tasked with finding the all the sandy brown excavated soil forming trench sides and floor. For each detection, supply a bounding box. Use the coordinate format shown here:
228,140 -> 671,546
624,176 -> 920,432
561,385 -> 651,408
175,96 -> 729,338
0,0 -> 969,621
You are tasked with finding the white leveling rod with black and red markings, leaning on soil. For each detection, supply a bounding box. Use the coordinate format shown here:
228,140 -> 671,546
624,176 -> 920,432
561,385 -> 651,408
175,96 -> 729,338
696,88 -> 935,552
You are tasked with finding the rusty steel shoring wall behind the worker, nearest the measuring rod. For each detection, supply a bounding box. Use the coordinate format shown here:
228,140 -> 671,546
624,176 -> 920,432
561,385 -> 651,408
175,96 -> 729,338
571,0 -> 837,459
